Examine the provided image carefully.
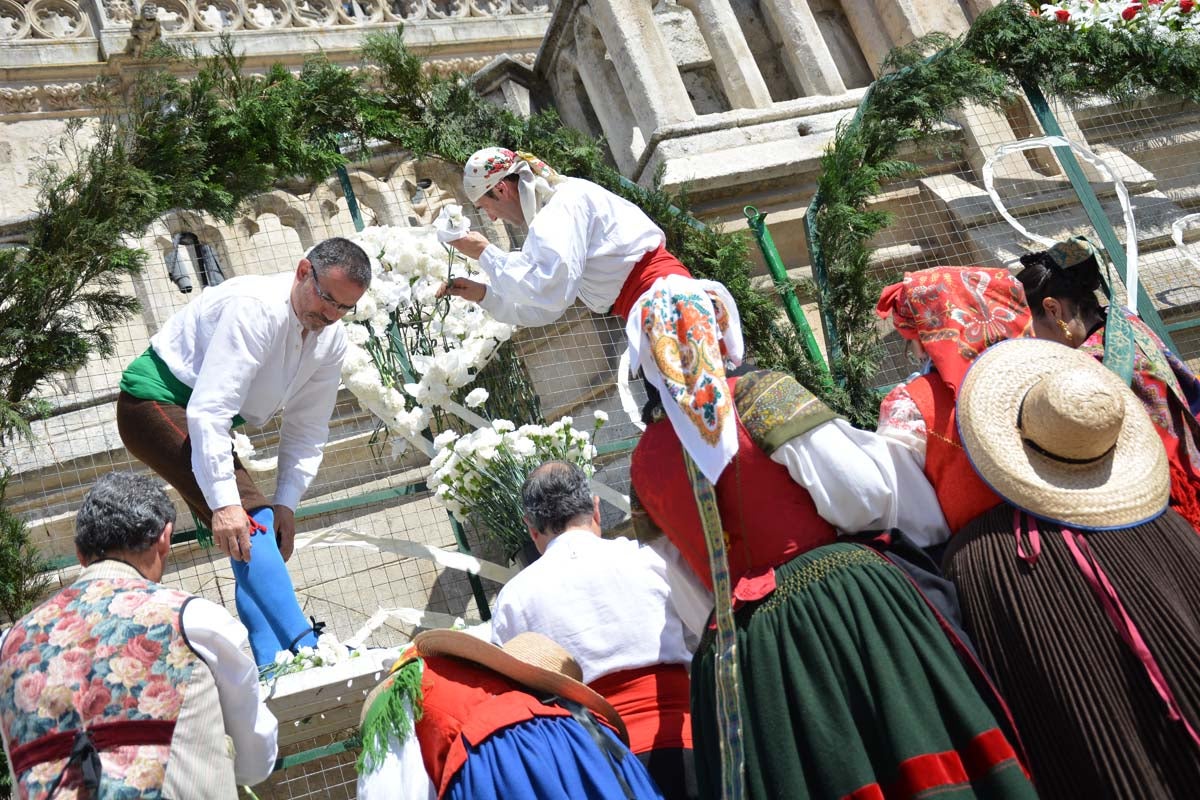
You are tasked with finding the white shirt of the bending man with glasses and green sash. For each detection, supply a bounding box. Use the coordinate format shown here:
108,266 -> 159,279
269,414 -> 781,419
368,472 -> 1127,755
150,272 -> 346,510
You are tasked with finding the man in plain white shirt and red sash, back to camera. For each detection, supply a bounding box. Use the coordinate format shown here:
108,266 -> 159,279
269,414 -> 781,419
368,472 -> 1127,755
492,461 -> 697,800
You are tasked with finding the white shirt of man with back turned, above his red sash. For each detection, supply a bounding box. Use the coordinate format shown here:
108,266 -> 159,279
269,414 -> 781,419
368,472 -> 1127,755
492,528 -> 691,684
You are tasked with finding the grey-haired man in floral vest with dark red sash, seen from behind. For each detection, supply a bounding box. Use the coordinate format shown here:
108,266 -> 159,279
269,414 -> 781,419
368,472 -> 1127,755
0,473 -> 278,800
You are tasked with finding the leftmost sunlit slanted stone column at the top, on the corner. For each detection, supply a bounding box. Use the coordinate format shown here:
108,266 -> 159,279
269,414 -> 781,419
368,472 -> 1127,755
588,0 -> 696,137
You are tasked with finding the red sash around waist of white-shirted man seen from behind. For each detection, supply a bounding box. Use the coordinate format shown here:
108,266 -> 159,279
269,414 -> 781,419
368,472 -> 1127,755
589,664 -> 691,753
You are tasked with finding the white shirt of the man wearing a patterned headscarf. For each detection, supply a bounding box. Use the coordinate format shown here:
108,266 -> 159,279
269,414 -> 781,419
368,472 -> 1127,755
479,178 -> 665,327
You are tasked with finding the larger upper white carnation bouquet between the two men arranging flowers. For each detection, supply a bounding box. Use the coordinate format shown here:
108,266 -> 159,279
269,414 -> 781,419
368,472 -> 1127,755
342,217 -> 514,456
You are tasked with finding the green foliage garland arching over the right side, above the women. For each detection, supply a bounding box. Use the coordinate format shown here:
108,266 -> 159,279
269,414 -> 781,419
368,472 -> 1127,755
816,1 -> 1200,426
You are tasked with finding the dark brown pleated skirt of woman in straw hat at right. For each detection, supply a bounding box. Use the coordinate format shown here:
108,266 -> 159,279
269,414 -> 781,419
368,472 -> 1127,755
944,504 -> 1200,800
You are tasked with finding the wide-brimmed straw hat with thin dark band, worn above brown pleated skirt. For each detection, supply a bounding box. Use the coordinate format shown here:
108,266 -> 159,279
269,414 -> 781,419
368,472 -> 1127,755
958,339 -> 1170,530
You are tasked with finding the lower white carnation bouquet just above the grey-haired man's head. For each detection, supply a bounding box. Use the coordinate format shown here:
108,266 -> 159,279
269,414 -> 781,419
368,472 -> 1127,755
427,411 -> 607,558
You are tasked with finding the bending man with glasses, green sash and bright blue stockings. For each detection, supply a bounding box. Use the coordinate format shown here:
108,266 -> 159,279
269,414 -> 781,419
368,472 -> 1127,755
116,237 -> 371,667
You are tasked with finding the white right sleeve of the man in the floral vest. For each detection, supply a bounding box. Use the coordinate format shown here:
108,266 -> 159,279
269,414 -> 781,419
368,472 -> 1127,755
181,597 -> 280,786
